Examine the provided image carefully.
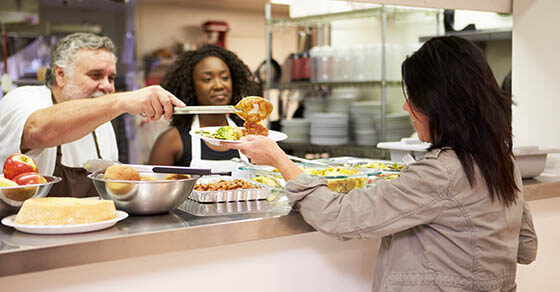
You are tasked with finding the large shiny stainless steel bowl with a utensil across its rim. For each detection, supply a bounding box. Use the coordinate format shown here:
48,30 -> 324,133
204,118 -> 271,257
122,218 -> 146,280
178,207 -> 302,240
88,173 -> 198,215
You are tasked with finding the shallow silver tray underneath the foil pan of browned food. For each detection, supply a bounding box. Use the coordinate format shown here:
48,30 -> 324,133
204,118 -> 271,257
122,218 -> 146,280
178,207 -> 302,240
179,200 -> 291,216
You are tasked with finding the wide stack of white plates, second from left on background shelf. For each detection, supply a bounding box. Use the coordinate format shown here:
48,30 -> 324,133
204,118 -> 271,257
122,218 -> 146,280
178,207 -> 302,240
311,113 -> 350,145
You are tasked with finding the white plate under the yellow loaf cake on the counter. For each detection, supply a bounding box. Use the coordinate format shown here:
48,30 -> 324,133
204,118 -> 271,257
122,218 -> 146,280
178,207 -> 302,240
2,210 -> 128,234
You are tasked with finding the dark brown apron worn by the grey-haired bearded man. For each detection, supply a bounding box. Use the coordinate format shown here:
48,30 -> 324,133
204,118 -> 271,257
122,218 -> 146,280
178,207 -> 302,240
48,94 -> 102,198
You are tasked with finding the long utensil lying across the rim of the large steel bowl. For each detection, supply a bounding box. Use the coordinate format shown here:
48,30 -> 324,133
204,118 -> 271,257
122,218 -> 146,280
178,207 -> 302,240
83,159 -> 231,176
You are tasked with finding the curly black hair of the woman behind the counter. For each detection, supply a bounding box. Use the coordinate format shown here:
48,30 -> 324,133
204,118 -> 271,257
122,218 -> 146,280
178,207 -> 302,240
161,45 -> 263,129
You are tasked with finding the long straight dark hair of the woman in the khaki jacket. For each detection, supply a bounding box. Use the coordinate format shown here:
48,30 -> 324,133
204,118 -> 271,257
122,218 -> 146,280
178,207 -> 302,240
401,36 -> 519,206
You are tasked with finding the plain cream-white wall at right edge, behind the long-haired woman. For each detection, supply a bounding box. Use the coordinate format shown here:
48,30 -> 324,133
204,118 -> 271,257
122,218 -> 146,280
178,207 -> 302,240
512,0 -> 560,171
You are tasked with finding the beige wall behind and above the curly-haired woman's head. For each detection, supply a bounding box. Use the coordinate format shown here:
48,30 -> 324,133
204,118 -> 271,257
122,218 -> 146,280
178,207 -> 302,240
136,3 -> 296,71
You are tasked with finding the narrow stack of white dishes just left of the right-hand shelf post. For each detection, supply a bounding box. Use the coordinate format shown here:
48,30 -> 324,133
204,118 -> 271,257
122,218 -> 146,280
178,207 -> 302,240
350,101 -> 381,146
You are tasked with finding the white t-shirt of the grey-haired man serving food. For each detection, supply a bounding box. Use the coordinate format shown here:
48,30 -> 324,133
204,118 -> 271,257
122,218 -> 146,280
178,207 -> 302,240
0,86 -> 119,175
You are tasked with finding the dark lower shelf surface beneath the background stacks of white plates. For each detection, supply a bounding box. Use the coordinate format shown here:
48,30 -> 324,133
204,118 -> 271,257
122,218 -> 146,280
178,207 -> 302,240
278,142 -> 390,159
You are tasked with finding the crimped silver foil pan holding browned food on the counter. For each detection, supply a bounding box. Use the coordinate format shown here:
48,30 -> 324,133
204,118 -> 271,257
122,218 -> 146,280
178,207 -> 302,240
189,176 -> 272,203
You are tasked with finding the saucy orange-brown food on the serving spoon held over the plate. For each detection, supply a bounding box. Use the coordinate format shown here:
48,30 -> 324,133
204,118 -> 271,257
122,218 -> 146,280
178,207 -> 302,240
235,96 -> 272,136
